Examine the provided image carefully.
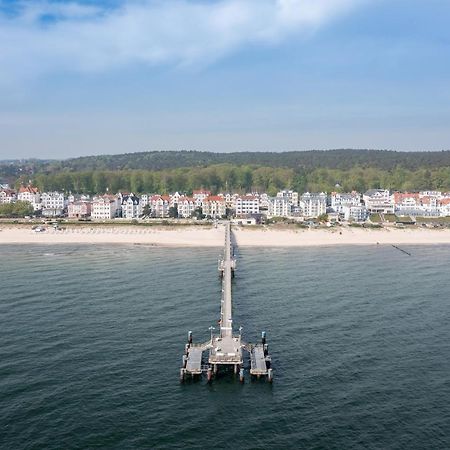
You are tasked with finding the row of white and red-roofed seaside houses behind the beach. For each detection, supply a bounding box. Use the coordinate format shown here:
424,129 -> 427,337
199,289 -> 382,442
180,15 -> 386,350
0,185 -> 450,222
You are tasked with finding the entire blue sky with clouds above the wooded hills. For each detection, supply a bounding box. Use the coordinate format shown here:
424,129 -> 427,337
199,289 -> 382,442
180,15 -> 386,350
0,0 -> 450,159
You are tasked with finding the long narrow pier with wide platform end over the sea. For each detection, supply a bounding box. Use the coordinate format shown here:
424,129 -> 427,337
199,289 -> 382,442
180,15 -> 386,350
180,222 -> 273,382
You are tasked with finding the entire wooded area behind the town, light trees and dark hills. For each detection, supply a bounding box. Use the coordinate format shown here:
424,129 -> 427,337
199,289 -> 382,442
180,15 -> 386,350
0,150 -> 450,195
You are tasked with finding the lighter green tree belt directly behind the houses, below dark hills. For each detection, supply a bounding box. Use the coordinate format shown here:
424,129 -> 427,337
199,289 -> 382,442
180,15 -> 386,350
15,164 -> 450,195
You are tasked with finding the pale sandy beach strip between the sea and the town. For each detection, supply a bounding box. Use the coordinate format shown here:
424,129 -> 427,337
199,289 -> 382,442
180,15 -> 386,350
0,225 -> 450,247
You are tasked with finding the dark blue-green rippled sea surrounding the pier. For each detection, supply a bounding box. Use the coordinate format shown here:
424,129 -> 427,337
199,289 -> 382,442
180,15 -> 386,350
0,245 -> 450,449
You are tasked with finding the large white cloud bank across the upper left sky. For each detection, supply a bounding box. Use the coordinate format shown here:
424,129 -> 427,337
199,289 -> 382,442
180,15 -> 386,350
0,0 -> 369,80
